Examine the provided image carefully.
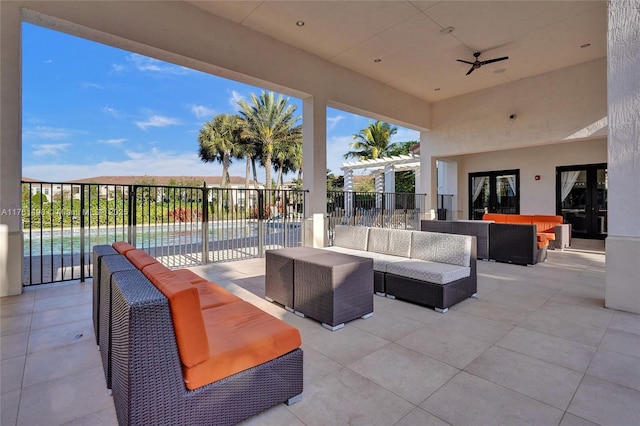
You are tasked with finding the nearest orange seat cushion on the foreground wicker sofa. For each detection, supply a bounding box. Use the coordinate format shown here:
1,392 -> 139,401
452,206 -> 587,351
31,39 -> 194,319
183,301 -> 302,389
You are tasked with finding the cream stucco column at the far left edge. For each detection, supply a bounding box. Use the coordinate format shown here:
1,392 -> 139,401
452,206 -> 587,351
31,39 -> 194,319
0,1 -> 23,296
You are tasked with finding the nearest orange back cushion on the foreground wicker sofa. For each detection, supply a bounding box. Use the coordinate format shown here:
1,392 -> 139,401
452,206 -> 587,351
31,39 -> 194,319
152,275 -> 209,368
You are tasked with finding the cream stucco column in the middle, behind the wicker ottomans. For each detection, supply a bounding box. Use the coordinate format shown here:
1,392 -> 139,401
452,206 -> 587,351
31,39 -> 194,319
302,96 -> 327,247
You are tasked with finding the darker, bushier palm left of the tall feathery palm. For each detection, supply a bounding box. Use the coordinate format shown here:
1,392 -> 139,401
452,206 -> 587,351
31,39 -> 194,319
198,114 -> 243,188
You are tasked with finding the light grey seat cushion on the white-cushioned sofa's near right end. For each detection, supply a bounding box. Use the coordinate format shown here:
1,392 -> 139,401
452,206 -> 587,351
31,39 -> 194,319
387,259 -> 471,284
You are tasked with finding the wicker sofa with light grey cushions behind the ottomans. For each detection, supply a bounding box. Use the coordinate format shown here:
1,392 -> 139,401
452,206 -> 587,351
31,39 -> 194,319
326,225 -> 477,313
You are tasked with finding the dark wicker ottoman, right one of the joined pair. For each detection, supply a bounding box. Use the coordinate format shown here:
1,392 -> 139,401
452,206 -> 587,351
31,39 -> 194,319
293,250 -> 373,331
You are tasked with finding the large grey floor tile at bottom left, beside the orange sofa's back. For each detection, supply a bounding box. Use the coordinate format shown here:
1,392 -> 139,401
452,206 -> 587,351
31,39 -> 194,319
18,367 -> 113,426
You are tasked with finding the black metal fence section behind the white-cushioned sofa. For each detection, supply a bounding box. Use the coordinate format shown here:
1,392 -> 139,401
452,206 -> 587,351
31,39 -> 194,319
327,191 -> 426,233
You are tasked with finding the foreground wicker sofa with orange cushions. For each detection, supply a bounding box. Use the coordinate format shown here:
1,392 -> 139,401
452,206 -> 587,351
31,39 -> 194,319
94,243 -> 303,425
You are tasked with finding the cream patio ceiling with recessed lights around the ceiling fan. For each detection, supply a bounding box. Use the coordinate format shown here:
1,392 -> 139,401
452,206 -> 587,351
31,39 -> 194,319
188,0 -> 607,102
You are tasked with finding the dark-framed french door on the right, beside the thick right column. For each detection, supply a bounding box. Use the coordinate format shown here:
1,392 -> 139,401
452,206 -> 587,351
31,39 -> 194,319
556,164 -> 608,239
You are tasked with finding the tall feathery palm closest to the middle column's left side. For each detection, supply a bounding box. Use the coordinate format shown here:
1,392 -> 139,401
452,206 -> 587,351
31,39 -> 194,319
238,92 -> 302,189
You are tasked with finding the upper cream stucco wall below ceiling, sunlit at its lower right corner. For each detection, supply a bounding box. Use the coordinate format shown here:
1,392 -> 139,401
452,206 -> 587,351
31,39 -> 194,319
421,59 -> 607,156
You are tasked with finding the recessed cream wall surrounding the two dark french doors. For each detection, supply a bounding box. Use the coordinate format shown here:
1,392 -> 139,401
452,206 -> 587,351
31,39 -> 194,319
456,139 -> 607,219
